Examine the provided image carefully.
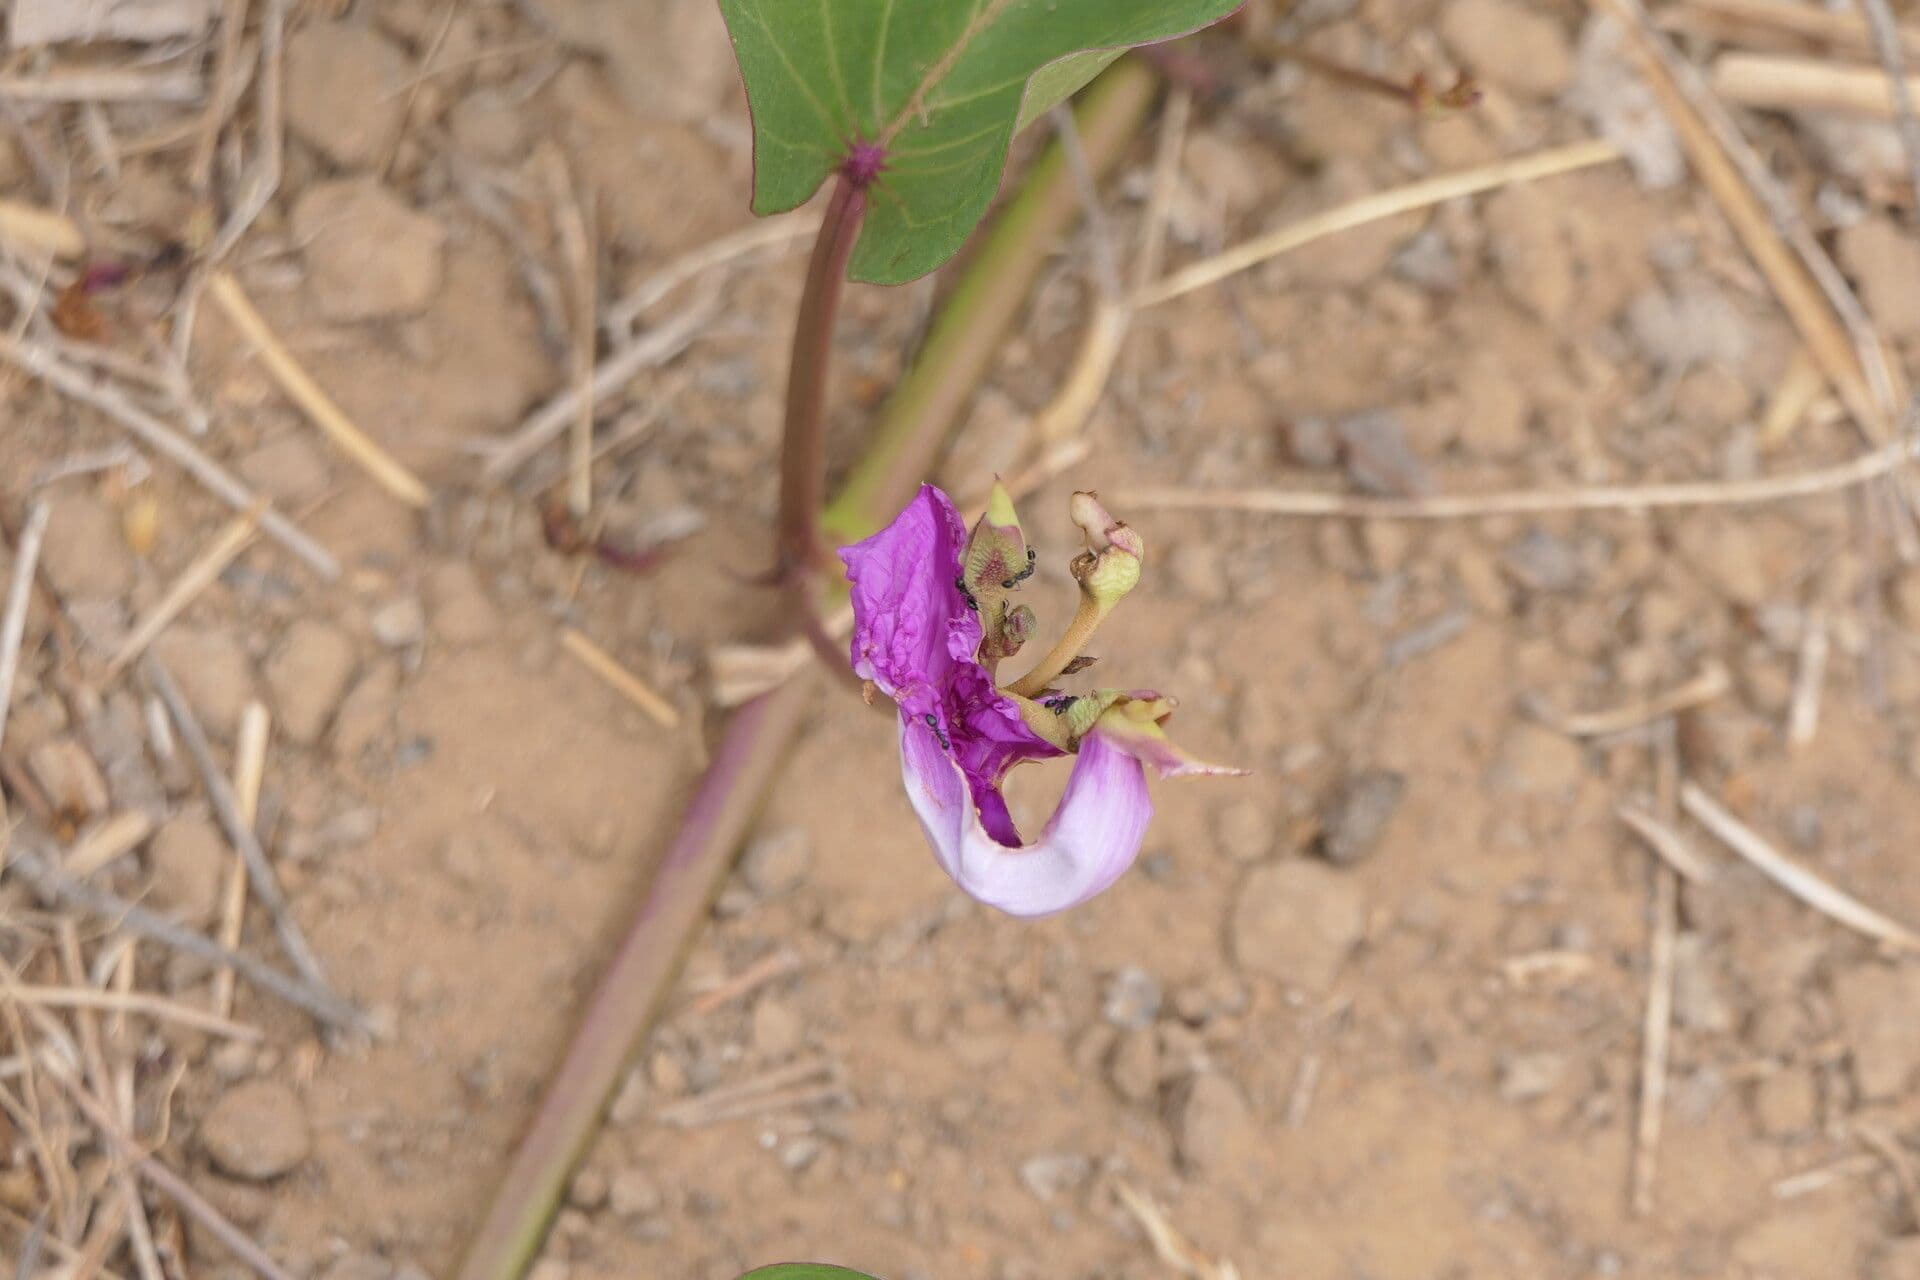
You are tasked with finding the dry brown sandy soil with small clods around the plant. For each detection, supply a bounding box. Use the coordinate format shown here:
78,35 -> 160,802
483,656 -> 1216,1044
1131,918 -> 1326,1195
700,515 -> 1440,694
11,0 -> 1920,1280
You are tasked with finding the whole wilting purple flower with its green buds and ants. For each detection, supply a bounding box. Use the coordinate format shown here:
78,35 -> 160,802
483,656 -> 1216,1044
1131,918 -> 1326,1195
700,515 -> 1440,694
841,486 -> 1244,915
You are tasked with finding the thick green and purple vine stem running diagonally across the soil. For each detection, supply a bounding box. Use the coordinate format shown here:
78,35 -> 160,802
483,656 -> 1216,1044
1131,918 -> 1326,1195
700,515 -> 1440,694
459,58 -> 1154,1280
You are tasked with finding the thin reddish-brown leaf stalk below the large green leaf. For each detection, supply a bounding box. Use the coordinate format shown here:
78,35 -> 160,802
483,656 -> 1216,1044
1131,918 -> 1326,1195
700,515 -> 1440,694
780,167 -> 866,575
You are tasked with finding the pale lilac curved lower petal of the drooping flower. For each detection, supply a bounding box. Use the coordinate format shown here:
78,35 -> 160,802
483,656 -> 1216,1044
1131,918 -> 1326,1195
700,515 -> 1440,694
900,718 -> 1154,915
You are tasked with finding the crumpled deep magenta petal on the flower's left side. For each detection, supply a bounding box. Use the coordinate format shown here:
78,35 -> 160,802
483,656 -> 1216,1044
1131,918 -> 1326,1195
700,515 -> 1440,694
839,484 -> 981,716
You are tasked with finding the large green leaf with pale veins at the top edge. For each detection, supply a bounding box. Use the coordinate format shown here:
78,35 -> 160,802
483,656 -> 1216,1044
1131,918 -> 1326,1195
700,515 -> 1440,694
720,0 -> 1238,284
